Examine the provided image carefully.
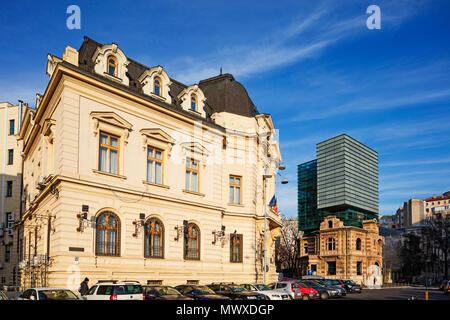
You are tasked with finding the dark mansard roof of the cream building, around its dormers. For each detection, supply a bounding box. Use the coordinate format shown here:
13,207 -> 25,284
78,36 -> 259,120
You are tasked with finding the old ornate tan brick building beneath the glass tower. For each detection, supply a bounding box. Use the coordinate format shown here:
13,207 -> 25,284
300,216 -> 384,285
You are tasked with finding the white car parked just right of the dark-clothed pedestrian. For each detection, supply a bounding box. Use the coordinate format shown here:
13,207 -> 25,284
85,280 -> 145,300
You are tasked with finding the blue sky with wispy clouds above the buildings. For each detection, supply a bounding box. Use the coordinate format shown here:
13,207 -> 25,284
0,0 -> 450,216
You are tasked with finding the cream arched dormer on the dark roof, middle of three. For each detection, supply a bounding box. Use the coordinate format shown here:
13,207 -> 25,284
138,66 -> 172,103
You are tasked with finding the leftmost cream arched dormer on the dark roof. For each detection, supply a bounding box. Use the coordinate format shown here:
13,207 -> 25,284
92,43 -> 129,85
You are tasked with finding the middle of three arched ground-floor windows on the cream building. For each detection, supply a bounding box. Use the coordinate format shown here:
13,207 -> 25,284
144,218 -> 164,258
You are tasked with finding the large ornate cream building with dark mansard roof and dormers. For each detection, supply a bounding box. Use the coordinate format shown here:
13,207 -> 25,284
17,37 -> 281,289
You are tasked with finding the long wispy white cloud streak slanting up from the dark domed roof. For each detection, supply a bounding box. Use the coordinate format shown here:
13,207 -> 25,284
167,1 -> 418,83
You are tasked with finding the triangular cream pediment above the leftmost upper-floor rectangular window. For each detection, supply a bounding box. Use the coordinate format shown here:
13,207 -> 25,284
91,112 -> 132,143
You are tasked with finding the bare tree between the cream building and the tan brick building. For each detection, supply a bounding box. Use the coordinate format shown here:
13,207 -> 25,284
277,217 -> 302,277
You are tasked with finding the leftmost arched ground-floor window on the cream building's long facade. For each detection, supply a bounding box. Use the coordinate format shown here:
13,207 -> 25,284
95,212 -> 120,256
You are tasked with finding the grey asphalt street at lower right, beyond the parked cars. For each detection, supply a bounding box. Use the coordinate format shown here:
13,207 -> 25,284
341,287 -> 450,300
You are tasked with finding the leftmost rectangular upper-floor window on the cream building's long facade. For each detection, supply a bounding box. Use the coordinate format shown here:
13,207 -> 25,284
98,132 -> 119,174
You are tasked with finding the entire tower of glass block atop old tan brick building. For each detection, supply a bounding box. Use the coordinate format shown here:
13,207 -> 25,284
298,134 -> 384,287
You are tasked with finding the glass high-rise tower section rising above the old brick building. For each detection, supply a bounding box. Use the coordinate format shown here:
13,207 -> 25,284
298,134 -> 378,233
